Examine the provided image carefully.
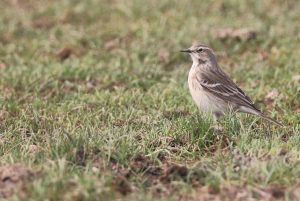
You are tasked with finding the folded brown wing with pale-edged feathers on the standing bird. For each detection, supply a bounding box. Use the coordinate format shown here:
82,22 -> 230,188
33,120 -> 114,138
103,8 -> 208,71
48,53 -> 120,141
196,69 -> 260,112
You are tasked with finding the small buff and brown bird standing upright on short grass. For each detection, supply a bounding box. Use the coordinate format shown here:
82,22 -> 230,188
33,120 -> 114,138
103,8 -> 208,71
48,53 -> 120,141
181,43 -> 283,126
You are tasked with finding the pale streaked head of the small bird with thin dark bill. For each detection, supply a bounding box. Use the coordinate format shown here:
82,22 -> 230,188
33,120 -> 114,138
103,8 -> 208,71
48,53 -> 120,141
181,44 -> 216,64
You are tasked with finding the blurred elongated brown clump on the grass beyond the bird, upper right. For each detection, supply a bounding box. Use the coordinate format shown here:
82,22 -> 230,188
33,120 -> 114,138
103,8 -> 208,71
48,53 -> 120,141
213,28 -> 257,41
